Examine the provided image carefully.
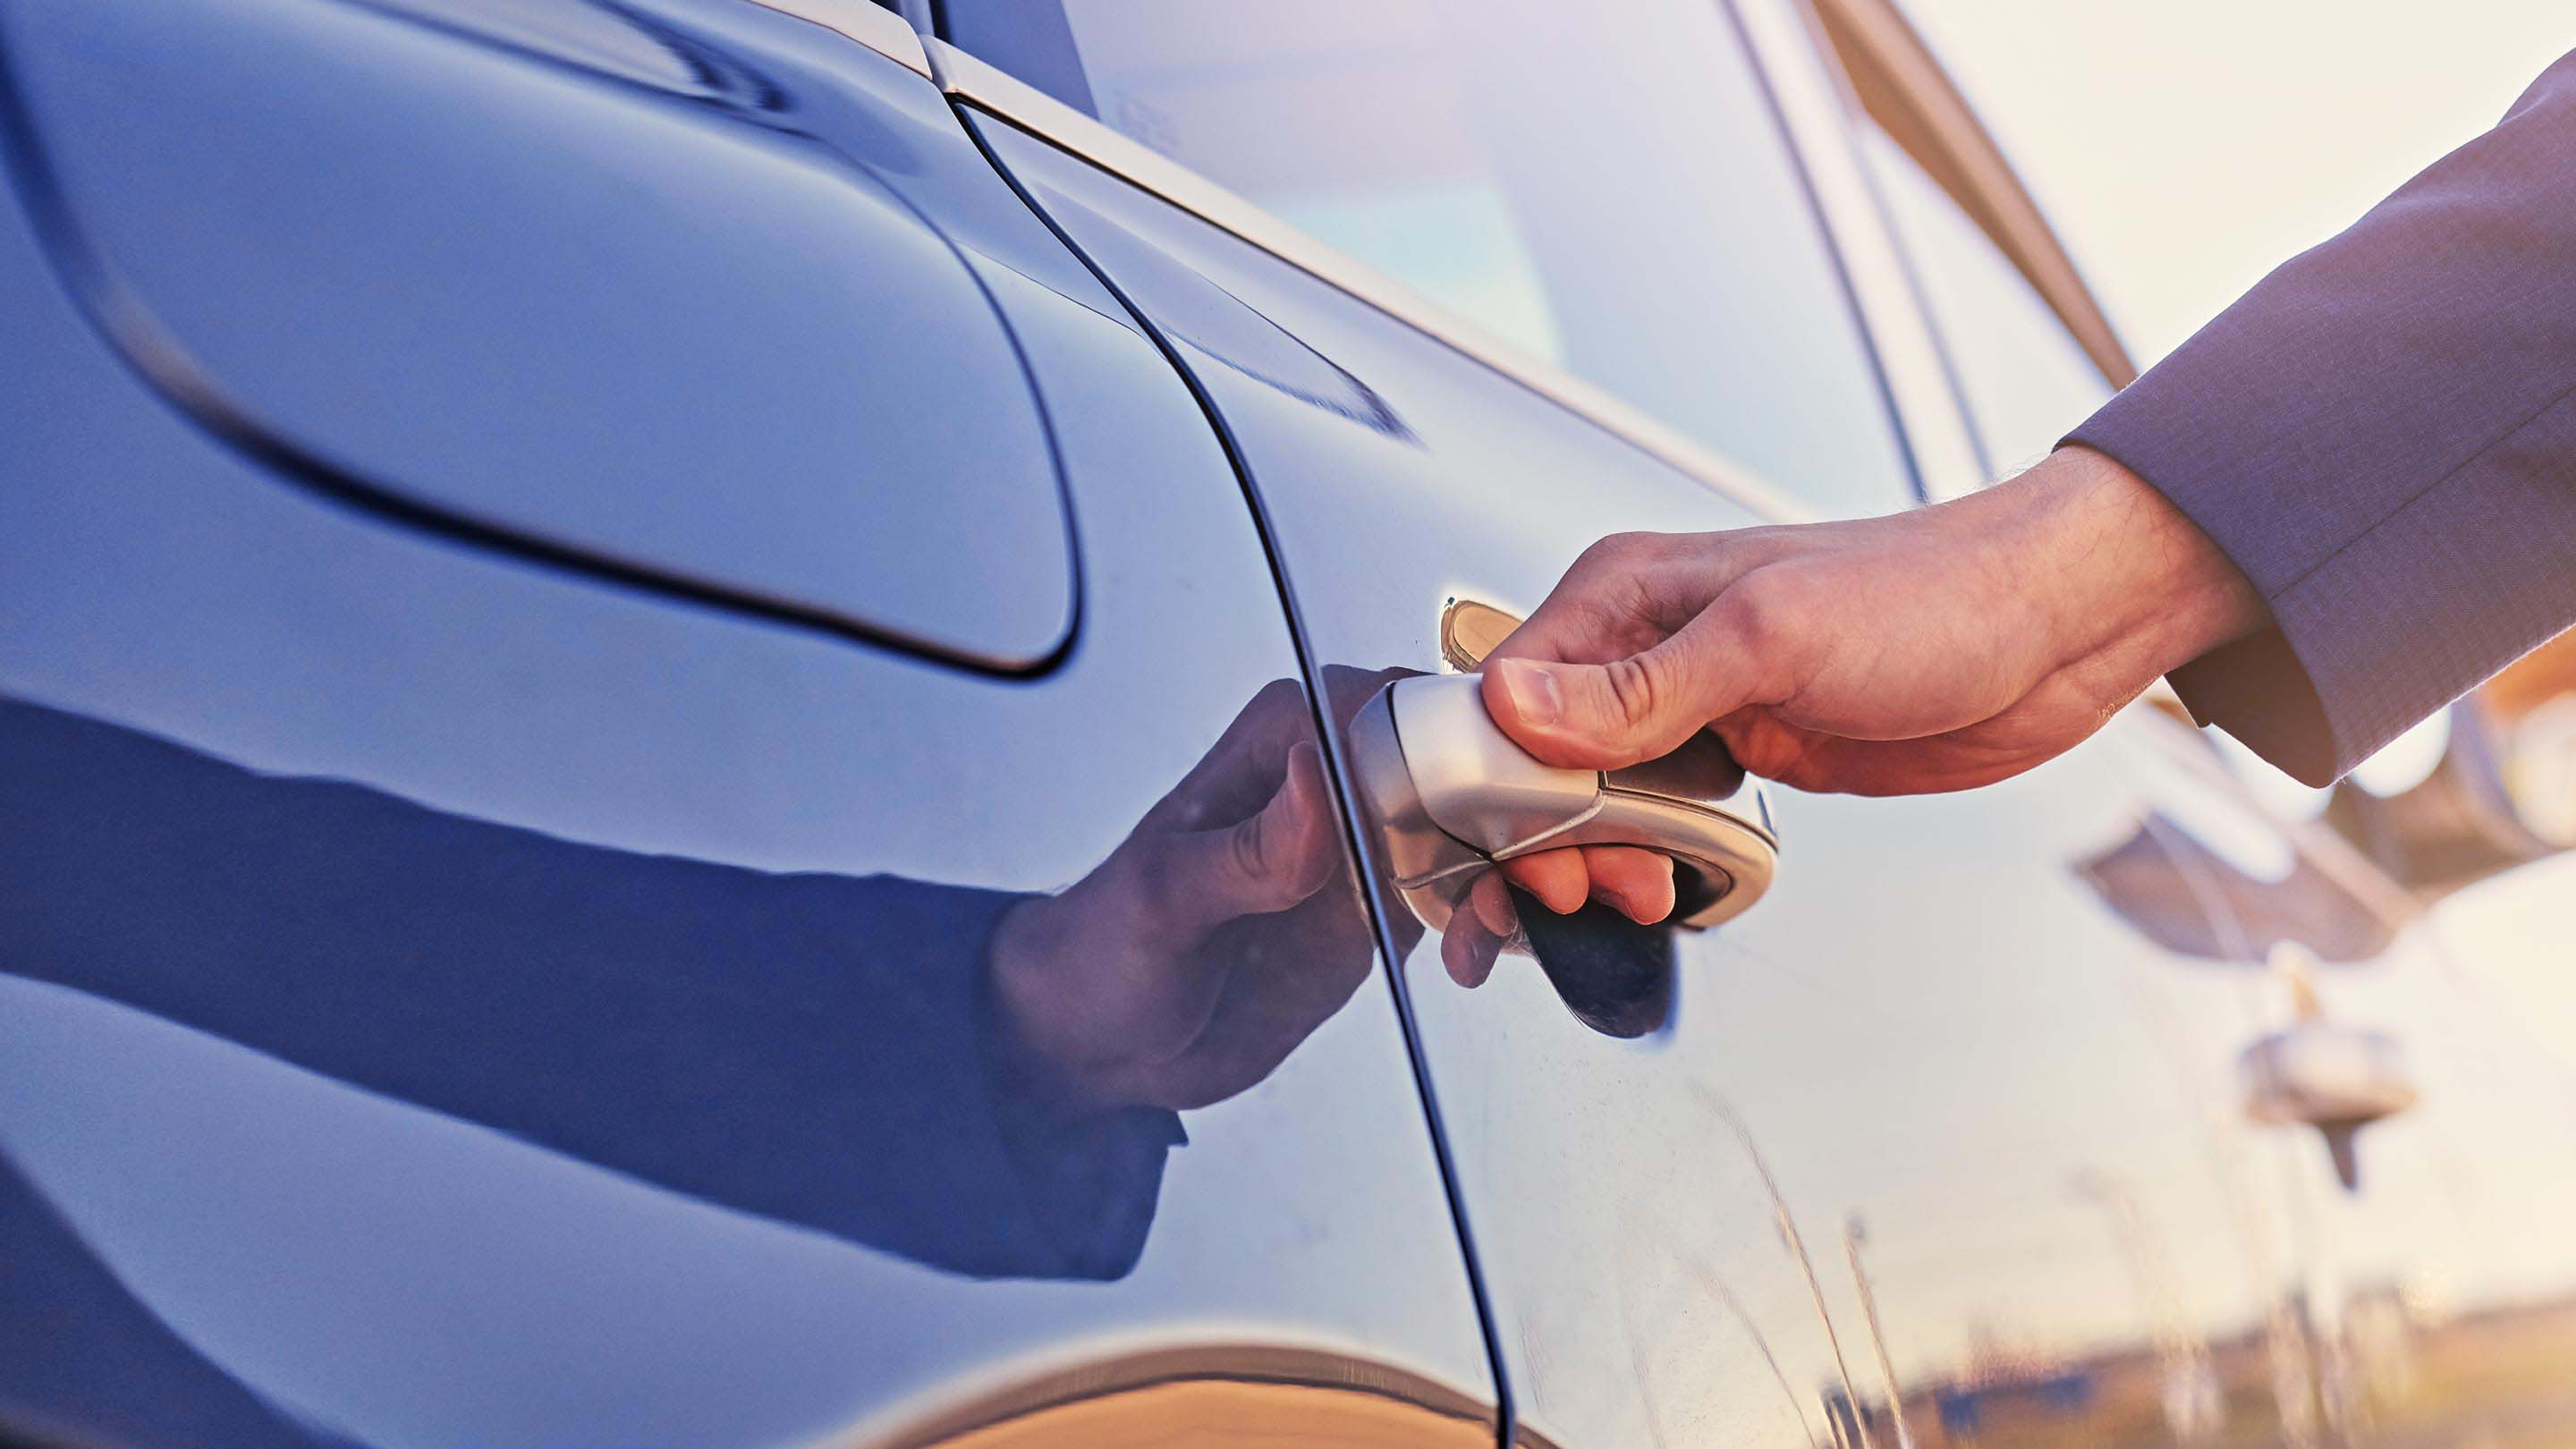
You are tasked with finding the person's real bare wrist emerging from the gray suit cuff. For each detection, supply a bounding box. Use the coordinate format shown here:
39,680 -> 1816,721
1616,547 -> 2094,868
2007,446 -> 2269,691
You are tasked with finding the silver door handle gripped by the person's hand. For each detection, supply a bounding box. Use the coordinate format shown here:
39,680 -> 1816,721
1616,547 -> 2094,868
1350,675 -> 1780,931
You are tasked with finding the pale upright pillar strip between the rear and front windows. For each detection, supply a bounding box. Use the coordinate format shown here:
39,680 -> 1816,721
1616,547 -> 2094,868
1733,0 -> 1991,503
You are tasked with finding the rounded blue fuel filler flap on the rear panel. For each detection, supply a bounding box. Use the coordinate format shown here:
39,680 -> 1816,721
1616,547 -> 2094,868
8,0 -> 1095,670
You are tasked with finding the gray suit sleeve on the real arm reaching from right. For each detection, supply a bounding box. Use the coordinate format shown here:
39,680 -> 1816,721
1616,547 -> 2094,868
2069,55 -> 2576,784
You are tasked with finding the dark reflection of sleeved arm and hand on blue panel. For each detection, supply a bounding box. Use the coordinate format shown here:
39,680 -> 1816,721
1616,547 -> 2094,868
0,670 -> 1669,1276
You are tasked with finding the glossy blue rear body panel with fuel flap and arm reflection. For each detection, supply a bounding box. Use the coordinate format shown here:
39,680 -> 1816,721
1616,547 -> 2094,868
0,0 -> 1496,1446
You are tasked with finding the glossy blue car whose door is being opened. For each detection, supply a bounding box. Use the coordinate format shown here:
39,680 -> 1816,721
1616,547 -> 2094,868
0,0 -> 2576,1449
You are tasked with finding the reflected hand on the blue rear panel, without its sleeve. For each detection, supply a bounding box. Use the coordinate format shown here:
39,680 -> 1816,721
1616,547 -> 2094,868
989,675 -> 1376,1111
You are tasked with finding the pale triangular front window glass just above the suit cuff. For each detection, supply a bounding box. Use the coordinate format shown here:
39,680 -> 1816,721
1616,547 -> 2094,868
1862,126 -> 2110,474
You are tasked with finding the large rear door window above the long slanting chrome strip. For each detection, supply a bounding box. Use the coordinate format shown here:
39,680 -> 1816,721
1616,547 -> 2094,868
948,0 -> 1909,513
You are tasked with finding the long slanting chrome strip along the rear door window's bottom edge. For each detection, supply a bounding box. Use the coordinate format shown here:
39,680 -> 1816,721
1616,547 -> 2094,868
922,36 -> 1816,523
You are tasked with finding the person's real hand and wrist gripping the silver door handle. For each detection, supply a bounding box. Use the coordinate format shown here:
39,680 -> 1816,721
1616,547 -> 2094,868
1484,449 -> 2265,789
